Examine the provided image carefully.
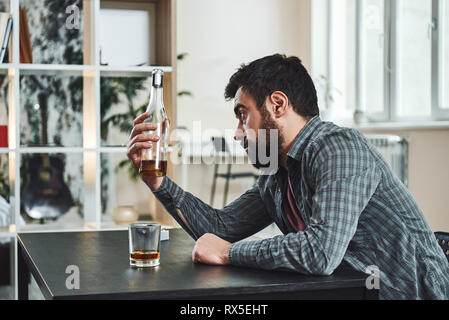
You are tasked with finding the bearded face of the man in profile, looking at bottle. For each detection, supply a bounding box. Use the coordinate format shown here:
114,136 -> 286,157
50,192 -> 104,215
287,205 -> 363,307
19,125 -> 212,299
234,88 -> 280,168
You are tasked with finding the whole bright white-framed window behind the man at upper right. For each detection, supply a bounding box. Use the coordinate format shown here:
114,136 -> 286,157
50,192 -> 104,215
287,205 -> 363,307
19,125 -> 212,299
312,0 -> 449,122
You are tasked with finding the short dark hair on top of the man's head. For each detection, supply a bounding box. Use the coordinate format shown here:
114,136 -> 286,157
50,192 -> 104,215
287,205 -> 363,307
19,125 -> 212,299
225,54 -> 320,118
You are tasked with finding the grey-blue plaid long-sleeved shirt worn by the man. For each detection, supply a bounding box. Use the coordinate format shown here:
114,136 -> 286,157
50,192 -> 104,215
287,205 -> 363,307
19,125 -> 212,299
154,116 -> 449,299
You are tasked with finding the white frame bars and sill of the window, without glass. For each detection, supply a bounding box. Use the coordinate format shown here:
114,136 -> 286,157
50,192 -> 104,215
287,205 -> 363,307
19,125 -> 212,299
323,0 -> 449,123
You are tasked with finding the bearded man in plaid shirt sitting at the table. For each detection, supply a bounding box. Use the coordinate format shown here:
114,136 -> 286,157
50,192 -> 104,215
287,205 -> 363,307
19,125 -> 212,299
128,54 -> 449,299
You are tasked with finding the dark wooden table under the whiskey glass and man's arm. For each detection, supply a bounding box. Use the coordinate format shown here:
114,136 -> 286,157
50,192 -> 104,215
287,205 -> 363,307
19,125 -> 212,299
17,230 -> 378,300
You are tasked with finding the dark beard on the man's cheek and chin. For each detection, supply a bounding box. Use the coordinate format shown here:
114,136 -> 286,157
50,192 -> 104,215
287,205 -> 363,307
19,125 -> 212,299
246,105 -> 283,170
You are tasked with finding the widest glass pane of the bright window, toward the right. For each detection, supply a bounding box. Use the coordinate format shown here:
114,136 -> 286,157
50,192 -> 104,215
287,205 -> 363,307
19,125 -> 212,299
392,0 -> 432,119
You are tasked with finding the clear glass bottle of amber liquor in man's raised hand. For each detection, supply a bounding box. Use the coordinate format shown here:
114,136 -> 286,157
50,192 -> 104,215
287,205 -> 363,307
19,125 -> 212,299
139,69 -> 170,177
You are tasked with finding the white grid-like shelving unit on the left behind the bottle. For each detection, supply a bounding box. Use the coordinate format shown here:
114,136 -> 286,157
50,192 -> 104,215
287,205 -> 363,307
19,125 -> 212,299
0,0 -> 176,298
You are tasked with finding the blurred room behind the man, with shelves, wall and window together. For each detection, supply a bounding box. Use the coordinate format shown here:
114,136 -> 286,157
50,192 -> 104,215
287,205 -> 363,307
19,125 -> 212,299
0,0 -> 449,299
